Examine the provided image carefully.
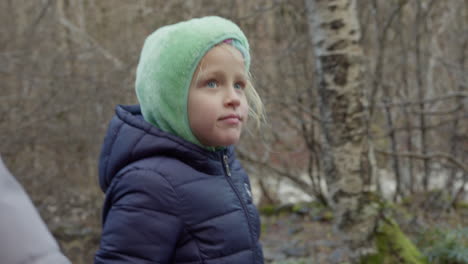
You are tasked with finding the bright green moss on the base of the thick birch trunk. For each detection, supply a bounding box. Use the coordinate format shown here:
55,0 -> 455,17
361,220 -> 427,264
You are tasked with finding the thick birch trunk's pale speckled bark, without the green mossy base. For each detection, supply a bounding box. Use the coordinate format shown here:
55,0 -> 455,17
306,0 -> 376,256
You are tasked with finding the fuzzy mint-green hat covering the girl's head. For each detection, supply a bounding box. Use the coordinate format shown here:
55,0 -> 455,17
135,16 -> 250,146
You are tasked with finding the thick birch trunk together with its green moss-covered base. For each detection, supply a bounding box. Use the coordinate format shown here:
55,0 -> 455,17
305,0 -> 421,263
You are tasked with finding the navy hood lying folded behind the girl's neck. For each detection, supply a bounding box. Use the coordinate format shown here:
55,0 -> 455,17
99,105 -> 234,192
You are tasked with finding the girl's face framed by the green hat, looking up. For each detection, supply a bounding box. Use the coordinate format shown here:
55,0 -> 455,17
188,44 -> 249,147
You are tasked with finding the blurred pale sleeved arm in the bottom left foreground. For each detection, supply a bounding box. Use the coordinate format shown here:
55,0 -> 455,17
0,157 -> 70,264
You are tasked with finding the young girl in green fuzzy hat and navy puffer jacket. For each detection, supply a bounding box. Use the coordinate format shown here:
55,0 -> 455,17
95,17 -> 263,264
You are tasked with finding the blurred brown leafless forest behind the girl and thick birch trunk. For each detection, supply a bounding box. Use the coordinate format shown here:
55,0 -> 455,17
0,0 -> 468,263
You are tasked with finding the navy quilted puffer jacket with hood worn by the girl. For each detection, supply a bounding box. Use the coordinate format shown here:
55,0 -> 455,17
95,106 -> 263,264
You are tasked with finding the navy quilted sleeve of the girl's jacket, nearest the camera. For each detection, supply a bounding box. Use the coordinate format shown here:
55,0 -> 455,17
95,170 -> 183,264
